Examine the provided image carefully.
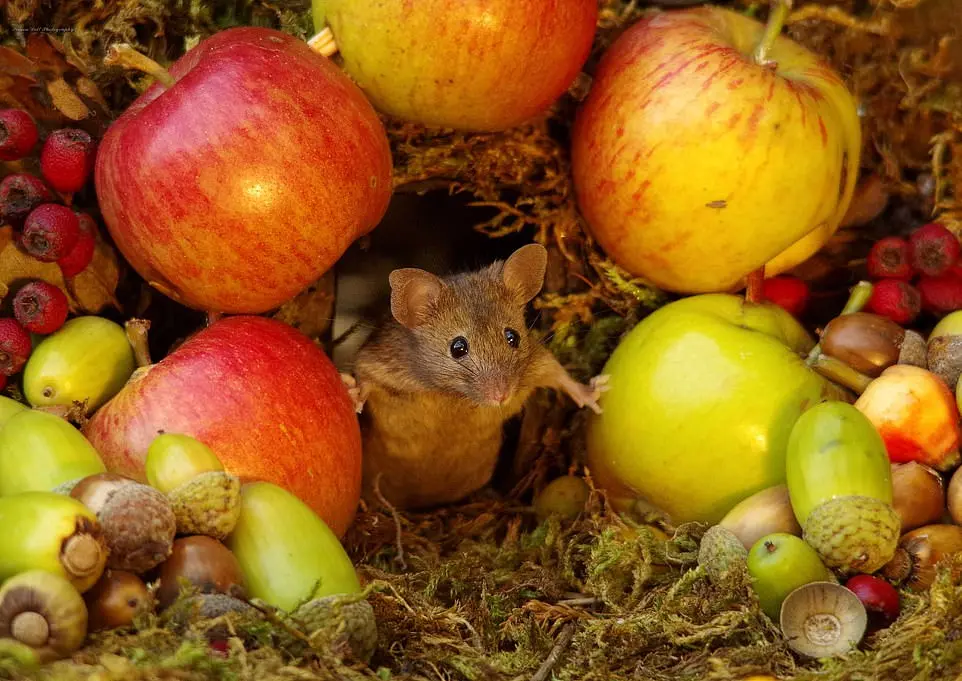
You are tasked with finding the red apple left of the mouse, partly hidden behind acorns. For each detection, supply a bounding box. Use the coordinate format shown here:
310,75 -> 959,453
84,316 -> 361,537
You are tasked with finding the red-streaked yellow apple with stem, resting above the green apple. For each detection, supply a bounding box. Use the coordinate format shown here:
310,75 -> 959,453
572,6 -> 861,293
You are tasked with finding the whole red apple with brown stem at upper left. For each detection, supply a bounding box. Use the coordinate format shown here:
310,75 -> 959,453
95,27 -> 392,314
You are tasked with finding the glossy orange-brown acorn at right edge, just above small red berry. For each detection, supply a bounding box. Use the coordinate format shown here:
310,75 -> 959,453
880,523 -> 962,591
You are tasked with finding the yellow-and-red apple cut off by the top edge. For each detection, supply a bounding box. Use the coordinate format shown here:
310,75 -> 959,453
313,0 -> 598,131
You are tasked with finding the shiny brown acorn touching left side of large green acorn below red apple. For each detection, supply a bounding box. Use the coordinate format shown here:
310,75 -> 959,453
155,535 -> 245,610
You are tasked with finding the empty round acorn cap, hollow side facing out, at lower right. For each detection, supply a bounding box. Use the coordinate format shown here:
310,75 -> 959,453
779,582 -> 868,659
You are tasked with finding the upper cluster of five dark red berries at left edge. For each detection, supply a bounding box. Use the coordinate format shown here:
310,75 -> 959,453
0,109 -> 97,278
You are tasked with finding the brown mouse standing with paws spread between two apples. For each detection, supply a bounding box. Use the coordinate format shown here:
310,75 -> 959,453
343,244 -> 607,508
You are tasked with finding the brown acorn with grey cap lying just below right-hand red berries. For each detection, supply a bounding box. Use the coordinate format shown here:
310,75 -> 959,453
819,312 -> 926,378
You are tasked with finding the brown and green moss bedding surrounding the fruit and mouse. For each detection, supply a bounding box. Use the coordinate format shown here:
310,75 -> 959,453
0,0 -> 962,681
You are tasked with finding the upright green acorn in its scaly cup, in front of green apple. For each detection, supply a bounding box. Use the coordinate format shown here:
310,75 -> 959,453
785,402 -> 901,575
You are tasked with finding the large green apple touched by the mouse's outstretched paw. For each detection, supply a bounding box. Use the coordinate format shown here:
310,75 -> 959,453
587,294 -> 852,523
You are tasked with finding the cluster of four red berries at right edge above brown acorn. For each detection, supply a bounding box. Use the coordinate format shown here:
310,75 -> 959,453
867,222 -> 962,326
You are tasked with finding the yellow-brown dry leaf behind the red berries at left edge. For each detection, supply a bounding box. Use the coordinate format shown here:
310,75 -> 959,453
0,226 -> 120,314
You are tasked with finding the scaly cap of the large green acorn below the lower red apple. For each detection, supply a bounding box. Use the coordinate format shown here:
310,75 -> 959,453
291,594 -> 377,663
